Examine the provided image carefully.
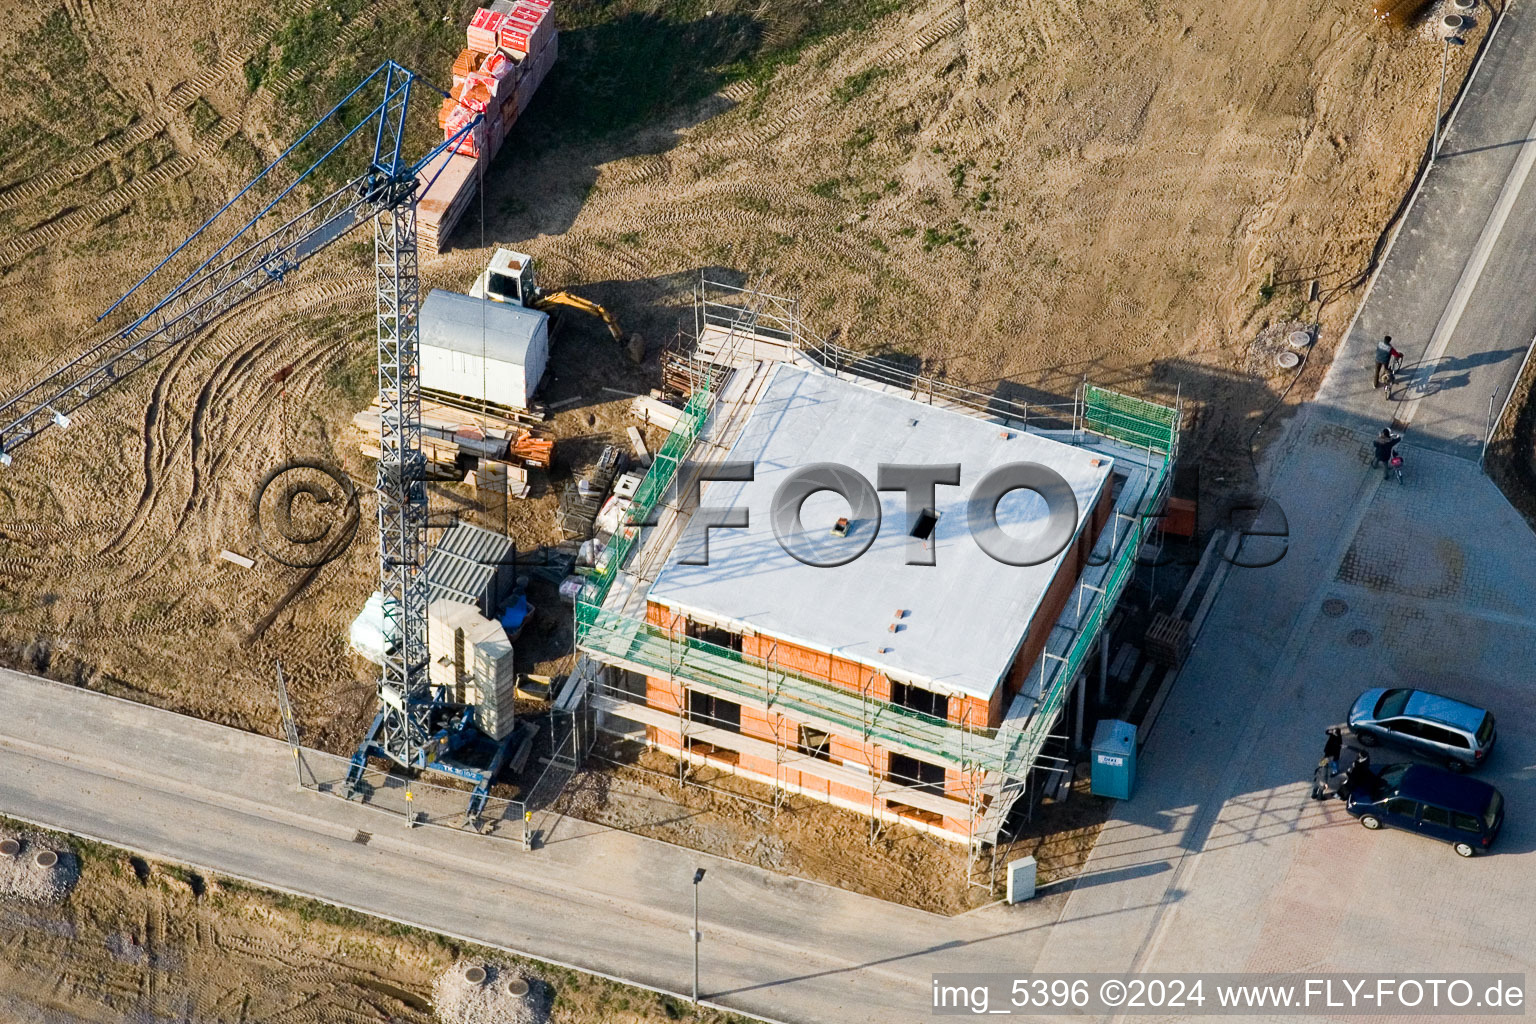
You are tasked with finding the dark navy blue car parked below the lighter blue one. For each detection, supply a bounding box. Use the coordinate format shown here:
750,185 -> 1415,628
1344,765 -> 1504,857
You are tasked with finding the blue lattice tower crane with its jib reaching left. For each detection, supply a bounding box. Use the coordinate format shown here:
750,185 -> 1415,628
0,61 -> 507,821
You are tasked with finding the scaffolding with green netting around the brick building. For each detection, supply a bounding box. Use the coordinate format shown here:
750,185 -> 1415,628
576,278 -> 1180,852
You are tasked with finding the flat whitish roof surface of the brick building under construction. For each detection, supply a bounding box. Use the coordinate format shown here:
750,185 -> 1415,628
650,364 -> 1112,699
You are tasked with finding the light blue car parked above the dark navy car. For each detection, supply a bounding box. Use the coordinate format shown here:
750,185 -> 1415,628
1349,688 -> 1498,772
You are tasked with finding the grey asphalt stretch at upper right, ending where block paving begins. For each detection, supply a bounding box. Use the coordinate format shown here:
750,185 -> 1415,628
1315,3 -> 1536,454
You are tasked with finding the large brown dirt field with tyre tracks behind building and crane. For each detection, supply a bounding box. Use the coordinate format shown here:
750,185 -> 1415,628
0,0 -> 1488,927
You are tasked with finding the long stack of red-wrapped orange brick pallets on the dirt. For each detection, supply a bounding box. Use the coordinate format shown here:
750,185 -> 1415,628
418,0 -> 559,253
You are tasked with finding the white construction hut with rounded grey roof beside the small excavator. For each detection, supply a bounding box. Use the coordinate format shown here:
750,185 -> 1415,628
421,289 -> 550,408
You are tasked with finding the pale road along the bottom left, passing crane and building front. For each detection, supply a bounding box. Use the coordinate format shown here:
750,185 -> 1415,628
0,671 -> 1064,1021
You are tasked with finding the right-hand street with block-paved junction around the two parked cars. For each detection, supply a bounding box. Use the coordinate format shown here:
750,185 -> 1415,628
1035,6 -> 1536,1007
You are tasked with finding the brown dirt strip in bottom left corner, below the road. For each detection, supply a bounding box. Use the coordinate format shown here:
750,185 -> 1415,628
0,829 -> 740,1024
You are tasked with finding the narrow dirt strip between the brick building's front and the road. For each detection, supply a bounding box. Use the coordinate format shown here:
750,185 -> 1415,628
553,742 -> 1109,913
